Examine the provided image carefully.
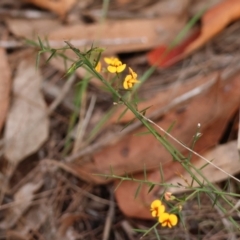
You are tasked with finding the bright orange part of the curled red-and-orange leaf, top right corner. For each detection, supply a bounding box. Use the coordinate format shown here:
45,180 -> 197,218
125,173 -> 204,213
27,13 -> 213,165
184,0 -> 240,55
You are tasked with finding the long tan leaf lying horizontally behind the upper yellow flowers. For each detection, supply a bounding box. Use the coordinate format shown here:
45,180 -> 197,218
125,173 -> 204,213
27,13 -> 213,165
48,17 -> 186,53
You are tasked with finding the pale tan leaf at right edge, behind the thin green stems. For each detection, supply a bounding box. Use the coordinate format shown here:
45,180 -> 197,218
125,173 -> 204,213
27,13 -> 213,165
168,141 -> 240,193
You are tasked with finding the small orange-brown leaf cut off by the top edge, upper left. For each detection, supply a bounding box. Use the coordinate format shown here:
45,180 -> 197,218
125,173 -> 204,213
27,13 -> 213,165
25,0 -> 76,17
